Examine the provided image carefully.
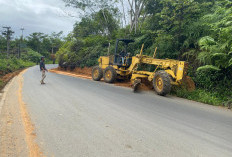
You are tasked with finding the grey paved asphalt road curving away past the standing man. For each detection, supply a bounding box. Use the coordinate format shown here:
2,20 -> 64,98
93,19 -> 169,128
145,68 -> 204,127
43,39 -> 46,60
23,66 -> 232,157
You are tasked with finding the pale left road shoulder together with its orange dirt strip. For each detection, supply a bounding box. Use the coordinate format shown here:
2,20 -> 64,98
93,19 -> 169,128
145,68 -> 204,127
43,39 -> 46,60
0,71 -> 42,157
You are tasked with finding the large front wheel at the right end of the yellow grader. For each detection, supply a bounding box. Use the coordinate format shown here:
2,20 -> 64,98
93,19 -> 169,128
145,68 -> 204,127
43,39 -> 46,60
153,70 -> 171,96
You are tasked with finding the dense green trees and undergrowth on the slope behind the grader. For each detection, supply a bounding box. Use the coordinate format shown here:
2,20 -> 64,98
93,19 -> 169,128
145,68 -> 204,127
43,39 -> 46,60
57,0 -> 232,105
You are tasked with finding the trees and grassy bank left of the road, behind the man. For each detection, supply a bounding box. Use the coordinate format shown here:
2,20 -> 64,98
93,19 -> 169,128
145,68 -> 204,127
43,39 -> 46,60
0,30 -> 63,89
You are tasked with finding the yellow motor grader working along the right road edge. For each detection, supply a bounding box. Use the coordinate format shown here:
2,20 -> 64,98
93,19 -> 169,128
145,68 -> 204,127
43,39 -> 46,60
92,39 -> 193,96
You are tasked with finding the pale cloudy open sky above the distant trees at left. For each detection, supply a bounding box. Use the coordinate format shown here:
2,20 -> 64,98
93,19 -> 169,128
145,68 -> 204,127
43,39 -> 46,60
0,0 -> 78,37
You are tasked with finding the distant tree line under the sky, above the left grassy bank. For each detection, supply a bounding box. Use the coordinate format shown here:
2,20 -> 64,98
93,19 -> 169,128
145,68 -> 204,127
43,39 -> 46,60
0,32 -> 63,60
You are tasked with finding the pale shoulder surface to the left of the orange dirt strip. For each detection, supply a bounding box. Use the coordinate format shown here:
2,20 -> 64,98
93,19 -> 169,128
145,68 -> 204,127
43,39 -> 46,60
0,76 -> 28,157
